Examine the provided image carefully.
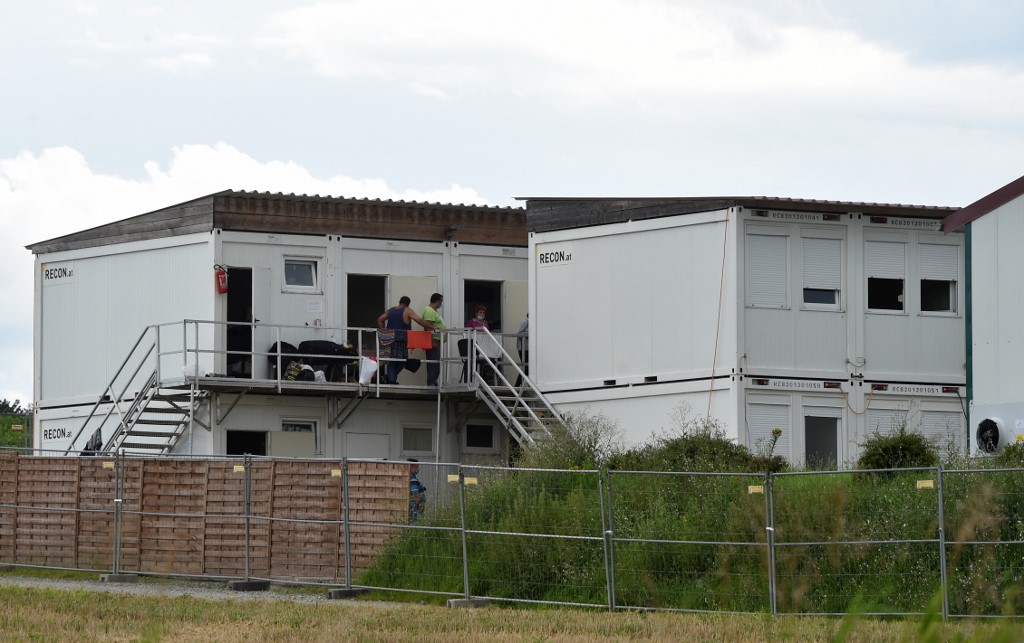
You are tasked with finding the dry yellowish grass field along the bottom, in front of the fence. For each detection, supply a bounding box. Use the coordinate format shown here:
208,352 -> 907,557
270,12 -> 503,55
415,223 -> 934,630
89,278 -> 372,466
0,586 -> 1024,642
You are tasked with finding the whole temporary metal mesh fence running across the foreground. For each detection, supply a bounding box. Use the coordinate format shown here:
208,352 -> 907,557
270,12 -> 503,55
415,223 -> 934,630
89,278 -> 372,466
6,446 -> 1024,617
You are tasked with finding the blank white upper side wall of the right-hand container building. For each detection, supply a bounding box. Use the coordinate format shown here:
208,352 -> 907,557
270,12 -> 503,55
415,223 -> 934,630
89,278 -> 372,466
531,216 -> 735,388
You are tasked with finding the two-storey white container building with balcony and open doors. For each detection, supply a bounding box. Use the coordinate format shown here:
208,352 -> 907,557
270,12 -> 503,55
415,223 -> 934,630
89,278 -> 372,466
29,190 -> 544,461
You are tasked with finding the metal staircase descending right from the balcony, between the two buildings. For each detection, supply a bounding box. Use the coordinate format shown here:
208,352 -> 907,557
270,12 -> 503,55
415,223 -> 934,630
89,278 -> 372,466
469,329 -> 564,444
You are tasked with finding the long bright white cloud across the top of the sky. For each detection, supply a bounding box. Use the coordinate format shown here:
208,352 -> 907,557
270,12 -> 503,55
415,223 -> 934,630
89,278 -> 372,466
255,0 -> 1024,119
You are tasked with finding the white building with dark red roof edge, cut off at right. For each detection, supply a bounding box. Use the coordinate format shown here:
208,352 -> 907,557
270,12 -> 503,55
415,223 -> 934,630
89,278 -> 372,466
942,170 -> 1024,452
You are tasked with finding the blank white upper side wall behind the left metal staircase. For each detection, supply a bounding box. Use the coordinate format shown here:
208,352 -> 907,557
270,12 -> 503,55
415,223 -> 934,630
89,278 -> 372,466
41,241 -> 215,400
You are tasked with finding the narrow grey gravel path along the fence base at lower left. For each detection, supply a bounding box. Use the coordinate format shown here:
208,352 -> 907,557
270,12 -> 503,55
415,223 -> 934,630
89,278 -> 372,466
0,574 -> 368,605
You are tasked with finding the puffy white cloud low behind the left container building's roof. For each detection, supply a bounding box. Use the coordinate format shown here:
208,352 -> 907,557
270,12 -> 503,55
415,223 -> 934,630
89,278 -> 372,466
0,142 -> 486,403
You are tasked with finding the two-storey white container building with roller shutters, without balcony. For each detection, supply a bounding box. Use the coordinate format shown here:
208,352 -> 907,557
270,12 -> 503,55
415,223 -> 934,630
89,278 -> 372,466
526,198 -> 966,466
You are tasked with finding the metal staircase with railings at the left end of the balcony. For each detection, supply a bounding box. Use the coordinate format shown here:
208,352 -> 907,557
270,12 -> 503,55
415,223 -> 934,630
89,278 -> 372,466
66,327 -> 209,455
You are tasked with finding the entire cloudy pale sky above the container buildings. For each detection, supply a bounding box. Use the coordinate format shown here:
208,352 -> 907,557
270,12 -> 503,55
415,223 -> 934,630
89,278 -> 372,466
0,0 -> 1024,403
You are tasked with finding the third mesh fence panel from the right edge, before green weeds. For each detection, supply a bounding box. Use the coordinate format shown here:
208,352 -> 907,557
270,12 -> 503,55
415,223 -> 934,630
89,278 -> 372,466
608,472 -> 769,611
